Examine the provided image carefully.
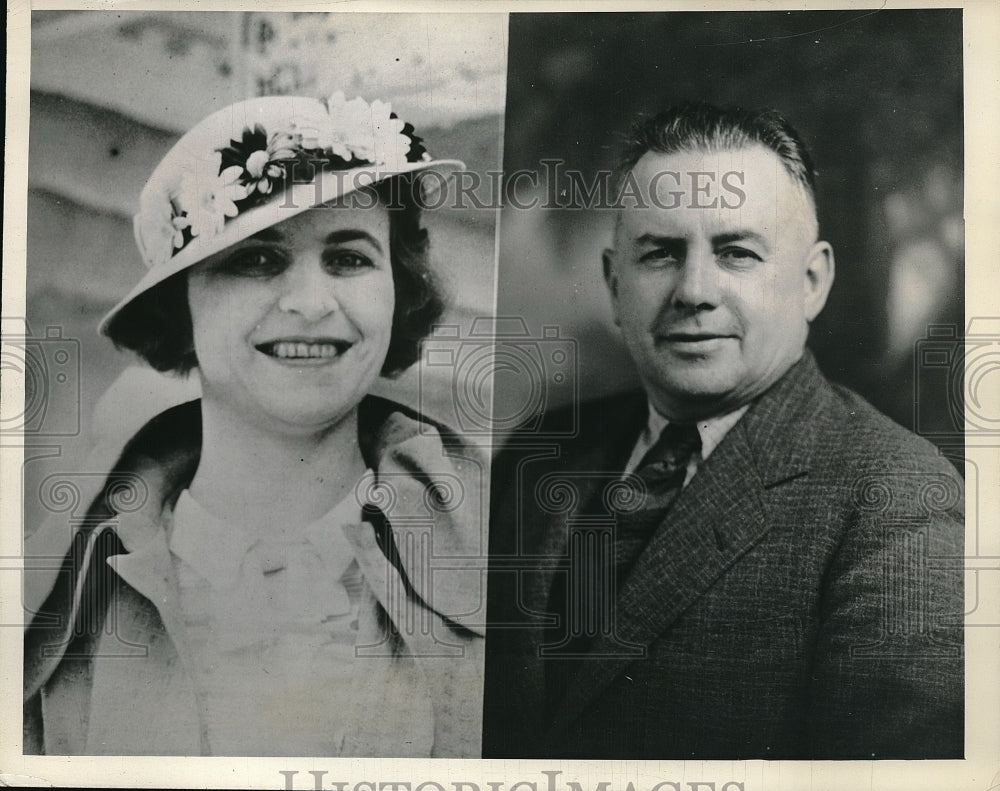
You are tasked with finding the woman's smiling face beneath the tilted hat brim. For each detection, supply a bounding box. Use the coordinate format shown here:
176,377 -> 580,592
188,198 -> 395,433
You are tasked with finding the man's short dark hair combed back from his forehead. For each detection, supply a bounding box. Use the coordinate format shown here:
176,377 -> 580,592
615,102 -> 816,204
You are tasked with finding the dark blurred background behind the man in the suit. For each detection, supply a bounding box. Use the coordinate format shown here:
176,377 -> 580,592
495,9 -> 964,458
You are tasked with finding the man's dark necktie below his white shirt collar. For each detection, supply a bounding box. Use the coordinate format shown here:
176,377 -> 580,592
614,423 -> 701,588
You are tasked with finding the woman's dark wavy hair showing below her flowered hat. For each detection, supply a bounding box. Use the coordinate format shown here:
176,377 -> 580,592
106,174 -> 444,376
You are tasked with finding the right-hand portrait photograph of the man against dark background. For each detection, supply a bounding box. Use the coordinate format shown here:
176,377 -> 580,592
486,9 -> 965,760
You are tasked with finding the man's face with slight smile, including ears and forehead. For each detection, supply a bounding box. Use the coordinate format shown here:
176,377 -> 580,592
604,146 -> 833,420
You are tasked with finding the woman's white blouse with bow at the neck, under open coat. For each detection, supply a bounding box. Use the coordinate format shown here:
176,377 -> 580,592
170,471 -> 371,756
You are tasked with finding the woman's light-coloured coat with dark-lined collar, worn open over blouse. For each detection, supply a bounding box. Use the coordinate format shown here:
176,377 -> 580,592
24,398 -> 489,757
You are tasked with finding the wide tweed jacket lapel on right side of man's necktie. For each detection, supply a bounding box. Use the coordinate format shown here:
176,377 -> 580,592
552,352 -> 826,733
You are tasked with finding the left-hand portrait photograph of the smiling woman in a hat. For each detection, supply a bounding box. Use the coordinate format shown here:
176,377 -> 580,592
5,6 -> 506,758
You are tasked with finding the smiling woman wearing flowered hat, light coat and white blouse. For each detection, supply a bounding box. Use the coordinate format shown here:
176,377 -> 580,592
25,94 -> 485,757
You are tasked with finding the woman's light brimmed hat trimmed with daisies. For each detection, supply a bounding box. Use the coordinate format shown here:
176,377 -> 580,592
100,91 -> 464,334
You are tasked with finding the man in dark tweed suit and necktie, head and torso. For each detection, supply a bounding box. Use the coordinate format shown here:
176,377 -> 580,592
485,104 -> 963,759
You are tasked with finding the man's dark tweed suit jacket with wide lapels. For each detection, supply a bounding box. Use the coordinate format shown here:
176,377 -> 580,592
484,352 -> 964,759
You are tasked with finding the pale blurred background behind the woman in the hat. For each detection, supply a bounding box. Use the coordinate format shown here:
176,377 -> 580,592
21,11 -> 507,529
